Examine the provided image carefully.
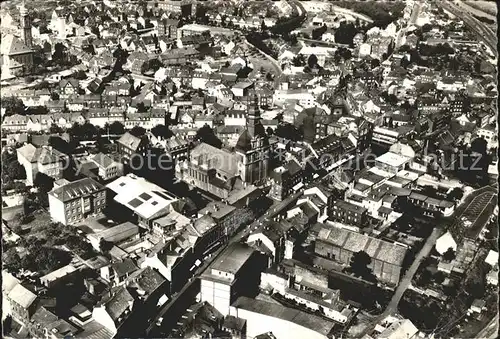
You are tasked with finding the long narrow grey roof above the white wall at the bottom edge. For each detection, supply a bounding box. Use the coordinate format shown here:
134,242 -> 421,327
231,297 -> 335,336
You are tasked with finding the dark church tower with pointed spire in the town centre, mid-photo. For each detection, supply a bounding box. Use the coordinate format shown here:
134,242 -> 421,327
235,95 -> 270,185
